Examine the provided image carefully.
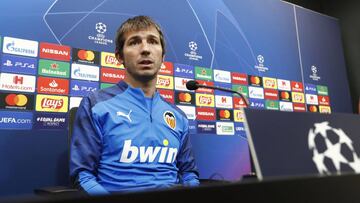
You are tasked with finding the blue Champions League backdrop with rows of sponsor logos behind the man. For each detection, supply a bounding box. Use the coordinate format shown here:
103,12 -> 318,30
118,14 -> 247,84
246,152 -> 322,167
0,0 -> 352,195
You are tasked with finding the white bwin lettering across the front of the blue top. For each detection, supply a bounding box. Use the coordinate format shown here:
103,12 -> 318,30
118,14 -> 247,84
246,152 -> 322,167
120,139 -> 178,163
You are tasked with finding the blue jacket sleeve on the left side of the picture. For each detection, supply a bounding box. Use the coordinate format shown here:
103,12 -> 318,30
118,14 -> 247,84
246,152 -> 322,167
70,97 -> 109,195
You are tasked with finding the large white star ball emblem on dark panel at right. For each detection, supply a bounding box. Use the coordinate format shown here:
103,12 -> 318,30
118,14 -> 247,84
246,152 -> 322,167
308,121 -> 360,175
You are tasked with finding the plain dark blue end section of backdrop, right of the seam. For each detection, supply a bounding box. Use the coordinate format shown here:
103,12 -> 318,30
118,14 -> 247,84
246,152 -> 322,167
296,8 -> 352,112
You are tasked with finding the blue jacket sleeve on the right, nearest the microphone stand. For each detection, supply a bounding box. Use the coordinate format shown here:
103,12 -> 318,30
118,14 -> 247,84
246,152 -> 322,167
177,119 -> 199,186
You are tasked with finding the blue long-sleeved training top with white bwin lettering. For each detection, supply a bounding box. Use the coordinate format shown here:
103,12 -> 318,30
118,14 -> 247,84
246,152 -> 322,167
70,81 -> 199,195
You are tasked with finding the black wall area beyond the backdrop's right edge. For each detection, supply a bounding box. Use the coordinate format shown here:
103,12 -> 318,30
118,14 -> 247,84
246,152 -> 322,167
286,0 -> 360,113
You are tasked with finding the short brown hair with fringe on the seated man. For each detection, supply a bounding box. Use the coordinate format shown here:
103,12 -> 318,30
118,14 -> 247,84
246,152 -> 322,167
115,16 -> 165,58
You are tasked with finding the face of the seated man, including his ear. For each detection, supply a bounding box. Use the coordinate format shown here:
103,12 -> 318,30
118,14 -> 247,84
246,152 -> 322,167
118,27 -> 163,82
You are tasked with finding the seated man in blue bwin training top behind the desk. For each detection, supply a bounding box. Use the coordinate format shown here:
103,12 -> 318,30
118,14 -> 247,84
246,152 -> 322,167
70,16 -> 199,195
